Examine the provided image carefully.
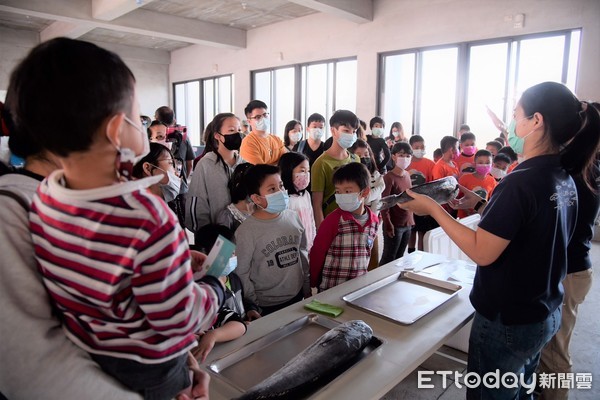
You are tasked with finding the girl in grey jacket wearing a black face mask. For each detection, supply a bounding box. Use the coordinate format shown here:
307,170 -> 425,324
185,113 -> 244,244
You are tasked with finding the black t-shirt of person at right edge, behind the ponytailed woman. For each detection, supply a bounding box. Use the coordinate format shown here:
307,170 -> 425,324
567,165 -> 600,274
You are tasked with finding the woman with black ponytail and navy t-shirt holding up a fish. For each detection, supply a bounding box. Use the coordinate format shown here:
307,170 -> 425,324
401,82 -> 600,400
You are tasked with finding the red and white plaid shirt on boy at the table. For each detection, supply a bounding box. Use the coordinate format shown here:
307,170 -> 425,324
310,207 -> 379,291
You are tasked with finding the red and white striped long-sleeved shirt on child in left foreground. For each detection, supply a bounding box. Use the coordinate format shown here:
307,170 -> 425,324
30,171 -> 219,364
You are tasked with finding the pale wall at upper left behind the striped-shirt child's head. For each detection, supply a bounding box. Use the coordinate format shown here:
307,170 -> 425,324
0,28 -> 171,117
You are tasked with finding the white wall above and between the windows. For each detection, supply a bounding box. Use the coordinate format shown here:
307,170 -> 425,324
170,0 -> 600,123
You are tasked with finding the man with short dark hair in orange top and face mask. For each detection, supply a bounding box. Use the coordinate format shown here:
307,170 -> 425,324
240,100 -> 287,165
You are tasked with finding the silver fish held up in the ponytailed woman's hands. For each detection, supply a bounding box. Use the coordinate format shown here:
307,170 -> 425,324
371,176 -> 459,212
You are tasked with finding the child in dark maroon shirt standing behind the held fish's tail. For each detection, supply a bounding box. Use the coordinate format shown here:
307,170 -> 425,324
381,142 -> 415,265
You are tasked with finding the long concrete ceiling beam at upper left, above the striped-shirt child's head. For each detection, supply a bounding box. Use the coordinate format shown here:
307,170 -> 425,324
0,0 -> 246,49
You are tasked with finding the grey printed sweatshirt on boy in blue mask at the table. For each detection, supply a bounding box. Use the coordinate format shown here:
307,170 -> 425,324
235,210 -> 310,306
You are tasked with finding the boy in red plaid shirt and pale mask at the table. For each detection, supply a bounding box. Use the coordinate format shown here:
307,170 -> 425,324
310,163 -> 379,292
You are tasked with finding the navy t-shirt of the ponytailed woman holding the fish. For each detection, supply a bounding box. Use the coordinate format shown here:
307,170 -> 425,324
470,155 -> 577,325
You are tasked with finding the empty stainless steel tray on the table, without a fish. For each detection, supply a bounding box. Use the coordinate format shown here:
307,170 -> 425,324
342,272 -> 462,325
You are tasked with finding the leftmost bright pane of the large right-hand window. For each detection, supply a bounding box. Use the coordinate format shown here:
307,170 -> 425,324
381,53 -> 415,136
